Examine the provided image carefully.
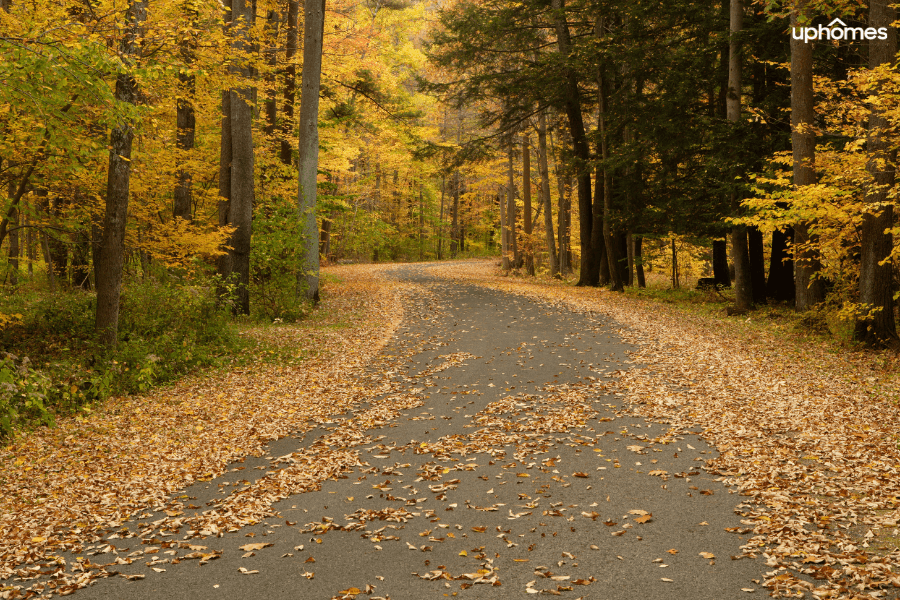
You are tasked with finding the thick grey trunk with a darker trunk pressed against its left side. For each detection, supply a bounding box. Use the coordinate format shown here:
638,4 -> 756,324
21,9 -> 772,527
228,0 -> 256,315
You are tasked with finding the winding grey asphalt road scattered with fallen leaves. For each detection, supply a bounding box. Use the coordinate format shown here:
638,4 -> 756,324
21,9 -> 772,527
77,266 -> 766,600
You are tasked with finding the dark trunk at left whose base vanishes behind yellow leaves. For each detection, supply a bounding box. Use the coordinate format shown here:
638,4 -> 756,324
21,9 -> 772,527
173,1 -> 197,221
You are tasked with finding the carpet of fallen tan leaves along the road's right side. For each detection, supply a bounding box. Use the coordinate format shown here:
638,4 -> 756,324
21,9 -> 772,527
431,262 -> 900,598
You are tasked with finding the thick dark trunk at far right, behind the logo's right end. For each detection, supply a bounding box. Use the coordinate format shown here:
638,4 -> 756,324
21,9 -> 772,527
853,0 -> 897,346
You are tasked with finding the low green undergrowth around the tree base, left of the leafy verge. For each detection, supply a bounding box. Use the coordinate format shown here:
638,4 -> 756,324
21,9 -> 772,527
0,280 -> 244,438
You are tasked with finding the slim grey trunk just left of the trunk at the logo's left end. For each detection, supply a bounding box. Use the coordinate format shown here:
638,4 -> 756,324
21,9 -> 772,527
725,0 -> 753,310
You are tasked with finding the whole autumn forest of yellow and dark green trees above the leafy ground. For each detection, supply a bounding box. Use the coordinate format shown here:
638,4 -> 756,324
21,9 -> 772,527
0,0 -> 900,435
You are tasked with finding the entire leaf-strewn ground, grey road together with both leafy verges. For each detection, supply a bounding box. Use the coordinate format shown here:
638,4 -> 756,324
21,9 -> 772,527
0,261 -> 900,600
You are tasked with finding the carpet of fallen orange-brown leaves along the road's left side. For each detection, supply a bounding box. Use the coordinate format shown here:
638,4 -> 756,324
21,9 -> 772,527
0,267 -> 402,597
